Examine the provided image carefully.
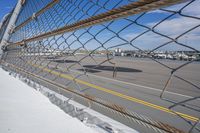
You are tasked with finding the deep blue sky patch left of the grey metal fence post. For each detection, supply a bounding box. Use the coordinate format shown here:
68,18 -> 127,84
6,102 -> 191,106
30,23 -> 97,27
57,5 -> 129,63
0,0 -> 17,21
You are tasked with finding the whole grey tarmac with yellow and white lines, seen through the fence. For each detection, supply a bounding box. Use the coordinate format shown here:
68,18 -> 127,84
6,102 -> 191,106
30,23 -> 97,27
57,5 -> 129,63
3,53 -> 200,131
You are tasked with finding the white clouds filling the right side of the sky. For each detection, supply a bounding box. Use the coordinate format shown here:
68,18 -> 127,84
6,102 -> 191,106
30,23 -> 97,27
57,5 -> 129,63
123,1 -> 200,50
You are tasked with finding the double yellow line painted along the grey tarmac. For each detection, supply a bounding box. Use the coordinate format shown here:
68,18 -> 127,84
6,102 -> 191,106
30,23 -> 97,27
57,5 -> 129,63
29,63 -> 199,122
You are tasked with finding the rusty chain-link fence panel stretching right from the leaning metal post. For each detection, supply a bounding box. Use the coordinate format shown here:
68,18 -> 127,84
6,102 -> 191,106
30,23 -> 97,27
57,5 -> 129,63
2,0 -> 200,132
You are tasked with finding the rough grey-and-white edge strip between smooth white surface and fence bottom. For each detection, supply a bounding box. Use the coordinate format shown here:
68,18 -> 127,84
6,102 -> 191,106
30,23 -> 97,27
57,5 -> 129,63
5,69 -> 139,133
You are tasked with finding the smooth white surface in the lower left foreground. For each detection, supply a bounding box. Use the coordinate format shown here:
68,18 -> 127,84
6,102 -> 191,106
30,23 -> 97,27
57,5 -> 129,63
0,68 -> 95,133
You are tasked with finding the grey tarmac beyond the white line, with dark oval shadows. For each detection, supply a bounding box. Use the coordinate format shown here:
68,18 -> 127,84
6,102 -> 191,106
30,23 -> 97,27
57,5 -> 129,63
37,56 -> 200,97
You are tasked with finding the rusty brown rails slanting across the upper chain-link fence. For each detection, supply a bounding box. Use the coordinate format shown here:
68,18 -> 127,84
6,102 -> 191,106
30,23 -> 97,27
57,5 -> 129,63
8,0 -> 183,45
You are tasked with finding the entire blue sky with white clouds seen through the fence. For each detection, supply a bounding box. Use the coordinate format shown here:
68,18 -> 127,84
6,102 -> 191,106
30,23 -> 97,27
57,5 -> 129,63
0,0 -> 200,50
